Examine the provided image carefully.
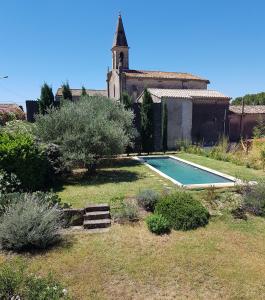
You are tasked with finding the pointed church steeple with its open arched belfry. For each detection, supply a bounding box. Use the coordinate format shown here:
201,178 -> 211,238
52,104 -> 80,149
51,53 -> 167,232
111,14 -> 129,70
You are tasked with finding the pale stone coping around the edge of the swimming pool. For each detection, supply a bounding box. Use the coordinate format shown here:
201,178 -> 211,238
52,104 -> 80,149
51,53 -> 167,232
133,154 -> 244,189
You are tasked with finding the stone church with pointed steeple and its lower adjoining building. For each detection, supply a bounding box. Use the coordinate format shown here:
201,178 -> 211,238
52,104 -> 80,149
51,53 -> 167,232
107,15 -> 230,150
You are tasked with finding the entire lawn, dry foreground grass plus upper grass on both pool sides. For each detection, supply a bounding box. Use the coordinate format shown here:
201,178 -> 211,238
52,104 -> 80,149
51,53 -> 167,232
0,153 -> 265,300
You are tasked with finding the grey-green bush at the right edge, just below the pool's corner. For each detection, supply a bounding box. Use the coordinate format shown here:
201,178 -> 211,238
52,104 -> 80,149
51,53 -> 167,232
243,180 -> 265,217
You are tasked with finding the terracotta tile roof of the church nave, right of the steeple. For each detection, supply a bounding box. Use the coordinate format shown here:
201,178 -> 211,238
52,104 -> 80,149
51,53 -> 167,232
123,70 -> 210,83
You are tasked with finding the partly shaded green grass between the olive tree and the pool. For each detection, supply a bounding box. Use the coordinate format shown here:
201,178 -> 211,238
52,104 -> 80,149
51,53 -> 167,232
58,158 -> 175,208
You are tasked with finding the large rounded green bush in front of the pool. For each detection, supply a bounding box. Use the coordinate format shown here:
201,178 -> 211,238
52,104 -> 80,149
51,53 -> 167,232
155,191 -> 210,230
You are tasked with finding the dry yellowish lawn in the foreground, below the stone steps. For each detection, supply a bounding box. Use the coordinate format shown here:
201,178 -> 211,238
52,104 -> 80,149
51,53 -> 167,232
0,215 -> 265,299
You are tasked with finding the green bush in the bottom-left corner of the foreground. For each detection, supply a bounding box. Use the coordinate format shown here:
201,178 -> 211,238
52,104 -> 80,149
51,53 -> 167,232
0,260 -> 70,300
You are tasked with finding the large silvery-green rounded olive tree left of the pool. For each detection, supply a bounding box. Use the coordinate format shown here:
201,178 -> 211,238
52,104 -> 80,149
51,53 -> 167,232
36,96 -> 134,171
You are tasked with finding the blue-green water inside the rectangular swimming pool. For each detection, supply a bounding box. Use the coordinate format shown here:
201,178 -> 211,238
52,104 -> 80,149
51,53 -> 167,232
143,157 -> 233,185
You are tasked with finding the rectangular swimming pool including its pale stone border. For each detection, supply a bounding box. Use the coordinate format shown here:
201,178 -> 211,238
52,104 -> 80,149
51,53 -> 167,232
137,155 -> 236,188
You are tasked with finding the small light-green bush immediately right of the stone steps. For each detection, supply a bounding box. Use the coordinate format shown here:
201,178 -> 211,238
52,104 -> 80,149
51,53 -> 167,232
111,197 -> 139,221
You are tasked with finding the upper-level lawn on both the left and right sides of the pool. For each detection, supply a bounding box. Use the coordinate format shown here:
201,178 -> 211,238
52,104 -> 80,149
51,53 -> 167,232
58,153 -> 265,208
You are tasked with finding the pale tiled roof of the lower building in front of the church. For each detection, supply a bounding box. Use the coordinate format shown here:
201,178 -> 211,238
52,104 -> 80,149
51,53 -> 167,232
137,88 -> 231,103
